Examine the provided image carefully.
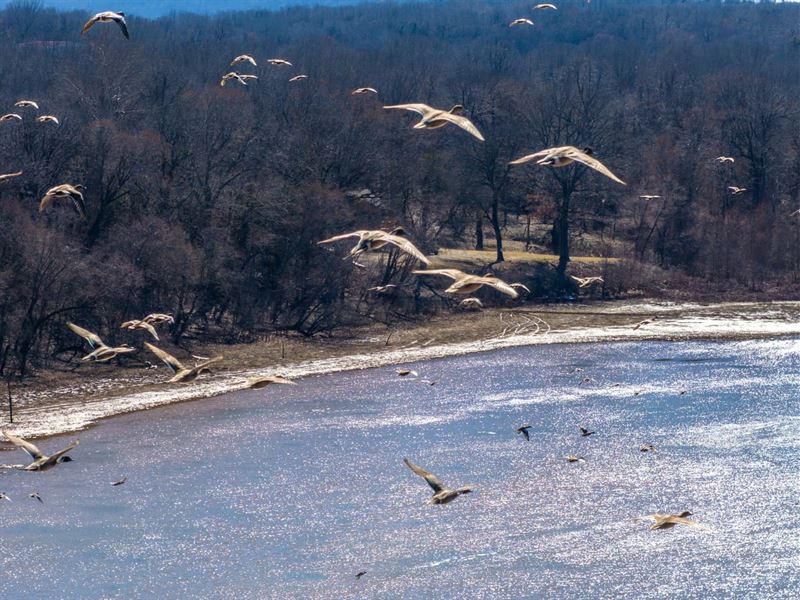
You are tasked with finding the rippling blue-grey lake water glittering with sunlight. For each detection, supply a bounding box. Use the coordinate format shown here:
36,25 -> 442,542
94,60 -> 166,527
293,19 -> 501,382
0,339 -> 800,599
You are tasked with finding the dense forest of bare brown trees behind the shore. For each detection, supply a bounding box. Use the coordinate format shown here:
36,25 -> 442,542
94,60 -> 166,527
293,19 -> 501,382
0,0 -> 800,374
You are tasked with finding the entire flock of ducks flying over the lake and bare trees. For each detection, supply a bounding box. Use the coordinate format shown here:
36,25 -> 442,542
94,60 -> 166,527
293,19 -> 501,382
0,5 -> 720,578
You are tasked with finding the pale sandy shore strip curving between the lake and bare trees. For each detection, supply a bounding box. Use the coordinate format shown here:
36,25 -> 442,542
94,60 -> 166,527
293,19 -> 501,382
0,301 -> 800,437
